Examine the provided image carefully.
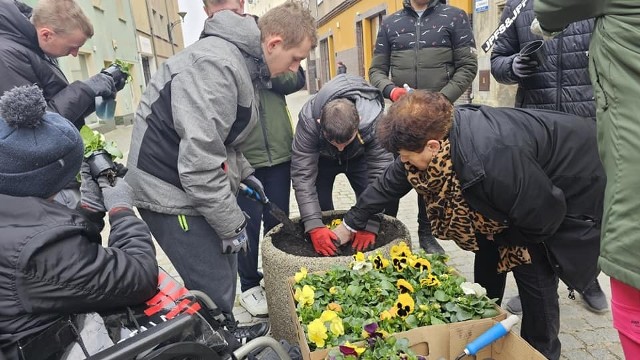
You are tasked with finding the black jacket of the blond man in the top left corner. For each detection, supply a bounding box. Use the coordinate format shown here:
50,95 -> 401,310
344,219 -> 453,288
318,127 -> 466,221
0,0 -> 95,128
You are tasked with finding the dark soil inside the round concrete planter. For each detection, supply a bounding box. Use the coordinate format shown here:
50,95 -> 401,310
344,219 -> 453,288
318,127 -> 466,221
271,214 -> 404,257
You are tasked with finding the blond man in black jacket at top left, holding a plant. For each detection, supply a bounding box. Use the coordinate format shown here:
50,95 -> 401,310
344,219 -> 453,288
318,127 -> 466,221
0,0 -> 117,129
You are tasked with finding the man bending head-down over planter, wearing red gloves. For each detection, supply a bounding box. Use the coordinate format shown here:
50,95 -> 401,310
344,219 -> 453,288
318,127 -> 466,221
291,74 -> 398,256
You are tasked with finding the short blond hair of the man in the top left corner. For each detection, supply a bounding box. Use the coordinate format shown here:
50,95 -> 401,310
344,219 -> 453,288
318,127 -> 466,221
31,0 -> 93,38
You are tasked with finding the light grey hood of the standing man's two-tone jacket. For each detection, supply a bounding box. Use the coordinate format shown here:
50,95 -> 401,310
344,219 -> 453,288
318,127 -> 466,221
201,10 -> 262,59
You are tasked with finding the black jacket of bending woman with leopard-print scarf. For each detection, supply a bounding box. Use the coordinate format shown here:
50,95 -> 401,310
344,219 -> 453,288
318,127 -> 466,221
345,105 -> 605,249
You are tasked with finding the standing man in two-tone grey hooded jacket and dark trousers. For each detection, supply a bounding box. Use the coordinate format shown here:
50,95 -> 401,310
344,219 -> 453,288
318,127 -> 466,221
127,3 -> 316,341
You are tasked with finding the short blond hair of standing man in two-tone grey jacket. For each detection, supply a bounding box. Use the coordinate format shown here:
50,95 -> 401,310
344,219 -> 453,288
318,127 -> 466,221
258,1 -> 318,49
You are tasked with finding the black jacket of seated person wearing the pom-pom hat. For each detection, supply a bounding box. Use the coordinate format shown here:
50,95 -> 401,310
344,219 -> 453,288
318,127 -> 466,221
0,195 -> 158,359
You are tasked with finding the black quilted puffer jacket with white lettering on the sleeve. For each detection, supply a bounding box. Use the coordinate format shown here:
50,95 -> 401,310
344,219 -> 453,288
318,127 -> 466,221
491,0 -> 596,120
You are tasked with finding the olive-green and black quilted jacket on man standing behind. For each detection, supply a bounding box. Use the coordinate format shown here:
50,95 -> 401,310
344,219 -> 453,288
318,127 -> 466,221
369,0 -> 478,102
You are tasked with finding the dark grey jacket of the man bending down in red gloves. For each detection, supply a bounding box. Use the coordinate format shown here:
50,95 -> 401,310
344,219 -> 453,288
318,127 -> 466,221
291,74 -> 393,232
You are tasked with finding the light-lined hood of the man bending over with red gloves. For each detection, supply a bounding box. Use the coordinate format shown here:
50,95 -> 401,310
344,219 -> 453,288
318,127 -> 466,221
302,74 -> 384,130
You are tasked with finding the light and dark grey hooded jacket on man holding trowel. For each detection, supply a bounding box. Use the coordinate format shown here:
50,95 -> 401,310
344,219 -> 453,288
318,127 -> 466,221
126,11 -> 269,238
